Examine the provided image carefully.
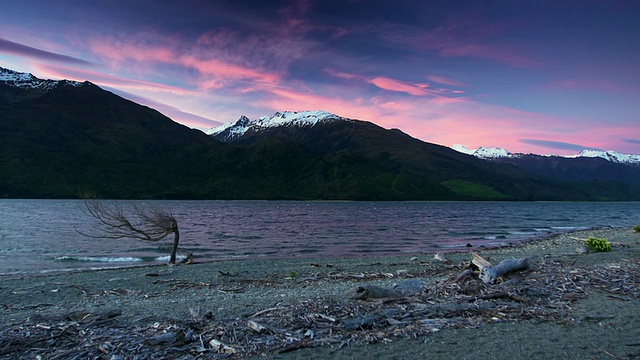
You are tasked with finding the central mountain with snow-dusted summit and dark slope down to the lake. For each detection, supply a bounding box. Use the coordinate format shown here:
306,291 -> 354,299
210,112 -> 600,200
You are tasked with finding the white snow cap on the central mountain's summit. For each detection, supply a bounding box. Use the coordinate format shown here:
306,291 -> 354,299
207,110 -> 347,140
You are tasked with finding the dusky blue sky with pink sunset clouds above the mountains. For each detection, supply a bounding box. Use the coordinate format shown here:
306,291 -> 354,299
0,0 -> 640,155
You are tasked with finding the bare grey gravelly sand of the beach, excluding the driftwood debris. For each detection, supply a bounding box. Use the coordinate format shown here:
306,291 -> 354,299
0,228 -> 640,359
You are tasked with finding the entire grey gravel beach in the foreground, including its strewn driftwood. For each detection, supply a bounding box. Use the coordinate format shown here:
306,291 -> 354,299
0,228 -> 640,359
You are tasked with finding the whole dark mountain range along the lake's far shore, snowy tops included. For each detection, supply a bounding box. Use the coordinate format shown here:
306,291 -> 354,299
0,68 -> 640,200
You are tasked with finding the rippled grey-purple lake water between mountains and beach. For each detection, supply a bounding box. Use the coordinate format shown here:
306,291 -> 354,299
0,200 -> 640,274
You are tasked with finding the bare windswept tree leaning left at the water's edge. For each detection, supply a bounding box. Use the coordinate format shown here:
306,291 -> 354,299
76,197 -> 185,264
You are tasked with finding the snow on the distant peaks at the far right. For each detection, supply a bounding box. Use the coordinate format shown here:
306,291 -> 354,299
452,144 -> 640,164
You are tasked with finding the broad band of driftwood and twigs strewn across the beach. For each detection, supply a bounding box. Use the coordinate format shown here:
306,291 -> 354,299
0,250 -> 640,359
